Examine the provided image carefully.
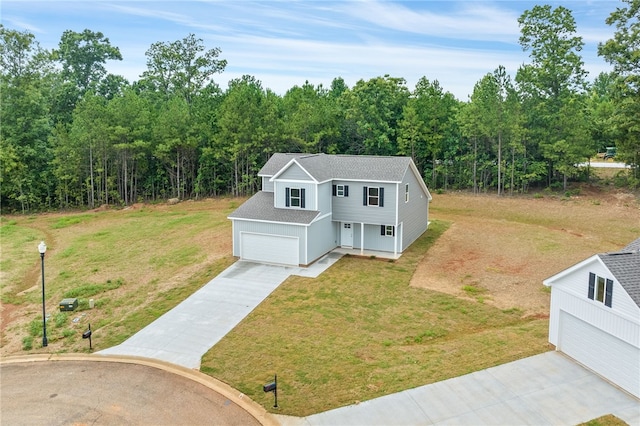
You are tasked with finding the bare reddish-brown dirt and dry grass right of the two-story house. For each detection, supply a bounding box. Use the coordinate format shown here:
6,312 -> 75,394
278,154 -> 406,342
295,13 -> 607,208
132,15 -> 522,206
411,191 -> 640,317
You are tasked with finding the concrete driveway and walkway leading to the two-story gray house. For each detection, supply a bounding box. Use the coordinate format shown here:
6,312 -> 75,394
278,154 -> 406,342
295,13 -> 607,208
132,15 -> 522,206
97,253 -> 341,369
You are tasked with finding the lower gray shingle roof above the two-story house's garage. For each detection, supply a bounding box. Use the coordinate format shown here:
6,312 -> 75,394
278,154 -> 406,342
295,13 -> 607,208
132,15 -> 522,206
229,191 -> 319,225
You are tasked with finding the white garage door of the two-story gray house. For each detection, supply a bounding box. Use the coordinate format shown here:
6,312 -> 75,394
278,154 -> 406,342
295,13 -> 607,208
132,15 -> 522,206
240,232 -> 300,266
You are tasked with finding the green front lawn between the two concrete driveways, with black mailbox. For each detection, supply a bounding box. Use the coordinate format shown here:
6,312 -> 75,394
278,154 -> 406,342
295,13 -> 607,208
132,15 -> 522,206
201,221 -> 549,416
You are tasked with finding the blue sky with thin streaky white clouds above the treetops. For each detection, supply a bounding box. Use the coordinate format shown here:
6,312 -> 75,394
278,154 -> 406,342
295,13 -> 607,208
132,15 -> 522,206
0,0 -> 623,100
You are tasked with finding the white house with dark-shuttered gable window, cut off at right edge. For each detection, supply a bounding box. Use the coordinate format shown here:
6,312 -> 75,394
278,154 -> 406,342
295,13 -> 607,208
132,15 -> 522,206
544,238 -> 640,398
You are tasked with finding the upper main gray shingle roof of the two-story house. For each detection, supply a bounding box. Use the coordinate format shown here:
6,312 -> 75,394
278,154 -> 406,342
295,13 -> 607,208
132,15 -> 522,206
258,153 -> 411,182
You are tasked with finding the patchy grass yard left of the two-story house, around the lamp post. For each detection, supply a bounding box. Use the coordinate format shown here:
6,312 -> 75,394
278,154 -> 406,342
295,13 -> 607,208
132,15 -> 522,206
0,199 -> 243,356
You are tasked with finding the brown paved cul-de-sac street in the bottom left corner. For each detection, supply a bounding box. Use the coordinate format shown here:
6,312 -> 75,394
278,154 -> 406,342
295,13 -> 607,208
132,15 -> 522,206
0,357 -> 273,426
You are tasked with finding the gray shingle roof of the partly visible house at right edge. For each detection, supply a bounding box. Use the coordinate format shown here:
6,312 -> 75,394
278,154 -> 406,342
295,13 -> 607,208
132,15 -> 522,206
598,238 -> 640,306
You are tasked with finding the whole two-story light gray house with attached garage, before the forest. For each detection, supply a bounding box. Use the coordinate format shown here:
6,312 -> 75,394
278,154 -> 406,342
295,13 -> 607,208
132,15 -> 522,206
229,153 -> 431,266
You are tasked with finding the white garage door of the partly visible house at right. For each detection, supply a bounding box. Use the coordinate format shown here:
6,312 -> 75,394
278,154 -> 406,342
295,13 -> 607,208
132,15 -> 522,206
558,311 -> 640,397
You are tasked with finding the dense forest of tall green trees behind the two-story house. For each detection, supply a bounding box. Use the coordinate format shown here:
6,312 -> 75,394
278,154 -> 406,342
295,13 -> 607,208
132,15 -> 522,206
0,0 -> 640,213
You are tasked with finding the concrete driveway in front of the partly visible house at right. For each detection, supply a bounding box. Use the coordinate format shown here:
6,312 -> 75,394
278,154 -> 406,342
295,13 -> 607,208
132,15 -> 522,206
278,352 -> 640,426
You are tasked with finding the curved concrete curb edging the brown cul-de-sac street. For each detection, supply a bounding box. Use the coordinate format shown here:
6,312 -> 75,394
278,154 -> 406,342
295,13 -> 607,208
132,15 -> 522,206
0,354 -> 280,426
